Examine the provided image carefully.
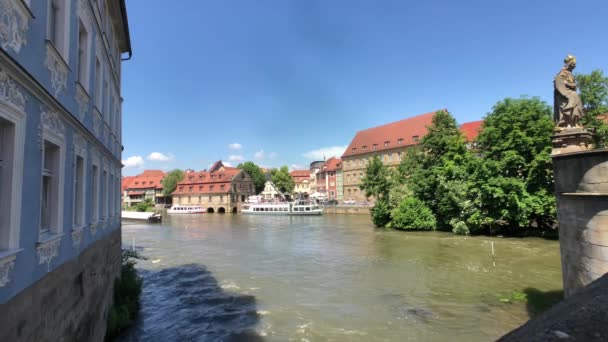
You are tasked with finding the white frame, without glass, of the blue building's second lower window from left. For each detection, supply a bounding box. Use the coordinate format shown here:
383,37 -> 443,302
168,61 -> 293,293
38,134 -> 65,241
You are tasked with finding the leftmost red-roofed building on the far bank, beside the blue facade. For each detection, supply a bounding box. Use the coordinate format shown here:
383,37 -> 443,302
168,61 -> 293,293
122,170 -> 168,208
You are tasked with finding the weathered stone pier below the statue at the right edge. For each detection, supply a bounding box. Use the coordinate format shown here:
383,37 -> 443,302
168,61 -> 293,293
553,150 -> 608,297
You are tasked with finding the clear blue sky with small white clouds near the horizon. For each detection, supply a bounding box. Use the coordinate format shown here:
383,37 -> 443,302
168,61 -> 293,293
122,0 -> 608,175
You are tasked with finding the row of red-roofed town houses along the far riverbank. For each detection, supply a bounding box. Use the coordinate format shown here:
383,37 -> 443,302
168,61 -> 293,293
122,112 -> 482,208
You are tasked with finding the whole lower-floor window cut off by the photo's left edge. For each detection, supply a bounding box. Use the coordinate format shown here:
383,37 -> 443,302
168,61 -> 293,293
0,116 -> 25,252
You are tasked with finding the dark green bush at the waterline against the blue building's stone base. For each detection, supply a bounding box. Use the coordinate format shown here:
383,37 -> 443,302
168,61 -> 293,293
106,250 -> 144,341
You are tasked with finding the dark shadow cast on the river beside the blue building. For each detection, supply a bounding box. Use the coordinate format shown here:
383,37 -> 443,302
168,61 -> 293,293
118,264 -> 264,341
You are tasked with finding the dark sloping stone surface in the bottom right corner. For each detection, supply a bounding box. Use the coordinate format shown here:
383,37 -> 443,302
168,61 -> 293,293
499,273 -> 608,342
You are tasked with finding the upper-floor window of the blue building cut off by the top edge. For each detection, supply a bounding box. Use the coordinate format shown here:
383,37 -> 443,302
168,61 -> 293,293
47,0 -> 70,61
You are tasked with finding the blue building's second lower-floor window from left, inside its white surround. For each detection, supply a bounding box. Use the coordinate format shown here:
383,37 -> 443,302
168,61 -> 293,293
40,140 -> 61,234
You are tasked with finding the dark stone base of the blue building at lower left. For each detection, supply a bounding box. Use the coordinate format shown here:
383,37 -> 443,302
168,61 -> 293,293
0,229 -> 121,342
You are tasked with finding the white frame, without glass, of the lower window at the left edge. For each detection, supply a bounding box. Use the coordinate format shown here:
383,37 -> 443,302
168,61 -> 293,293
0,101 -> 26,254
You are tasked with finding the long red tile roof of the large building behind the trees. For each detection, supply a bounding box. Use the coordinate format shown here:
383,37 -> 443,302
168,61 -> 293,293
342,111 -> 437,158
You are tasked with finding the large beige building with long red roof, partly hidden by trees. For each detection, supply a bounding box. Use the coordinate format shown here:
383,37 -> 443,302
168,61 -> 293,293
342,111 -> 482,202
